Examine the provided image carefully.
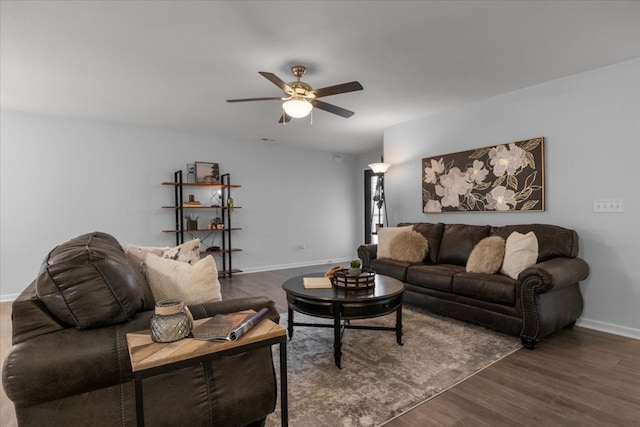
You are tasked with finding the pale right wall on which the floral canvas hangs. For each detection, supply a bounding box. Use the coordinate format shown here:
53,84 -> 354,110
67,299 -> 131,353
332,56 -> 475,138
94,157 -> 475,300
384,59 -> 640,338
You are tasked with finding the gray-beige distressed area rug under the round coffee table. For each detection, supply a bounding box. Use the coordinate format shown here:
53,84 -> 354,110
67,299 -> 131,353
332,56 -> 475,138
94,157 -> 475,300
266,305 -> 521,427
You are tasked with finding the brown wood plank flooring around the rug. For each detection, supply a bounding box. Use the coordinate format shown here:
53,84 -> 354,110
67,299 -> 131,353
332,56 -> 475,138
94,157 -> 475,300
0,265 -> 640,427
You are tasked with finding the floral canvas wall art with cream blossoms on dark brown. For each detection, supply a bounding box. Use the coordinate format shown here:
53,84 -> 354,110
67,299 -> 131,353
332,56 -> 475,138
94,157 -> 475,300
422,137 -> 544,213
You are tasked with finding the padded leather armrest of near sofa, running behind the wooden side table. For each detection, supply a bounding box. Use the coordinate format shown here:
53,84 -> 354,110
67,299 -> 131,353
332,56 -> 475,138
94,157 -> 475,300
2,297 -> 279,406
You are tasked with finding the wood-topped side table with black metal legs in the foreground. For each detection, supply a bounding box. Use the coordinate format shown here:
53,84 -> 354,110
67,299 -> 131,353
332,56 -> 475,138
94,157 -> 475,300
127,312 -> 288,427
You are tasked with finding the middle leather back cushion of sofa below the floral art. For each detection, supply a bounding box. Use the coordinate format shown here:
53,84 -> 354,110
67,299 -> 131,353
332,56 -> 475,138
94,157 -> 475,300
438,224 -> 491,266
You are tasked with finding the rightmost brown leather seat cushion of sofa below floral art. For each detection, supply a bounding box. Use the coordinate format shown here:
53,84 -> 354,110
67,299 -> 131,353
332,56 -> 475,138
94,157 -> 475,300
453,272 -> 516,306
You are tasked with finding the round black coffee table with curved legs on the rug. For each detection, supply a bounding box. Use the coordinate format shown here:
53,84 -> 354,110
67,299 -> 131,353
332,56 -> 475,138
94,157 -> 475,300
282,273 -> 404,368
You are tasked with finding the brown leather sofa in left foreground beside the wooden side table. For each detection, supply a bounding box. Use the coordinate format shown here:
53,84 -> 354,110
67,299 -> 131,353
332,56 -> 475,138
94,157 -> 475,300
2,232 -> 279,426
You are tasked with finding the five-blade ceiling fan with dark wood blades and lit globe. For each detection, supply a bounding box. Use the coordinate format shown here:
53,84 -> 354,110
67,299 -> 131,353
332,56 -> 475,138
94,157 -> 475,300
227,65 -> 363,123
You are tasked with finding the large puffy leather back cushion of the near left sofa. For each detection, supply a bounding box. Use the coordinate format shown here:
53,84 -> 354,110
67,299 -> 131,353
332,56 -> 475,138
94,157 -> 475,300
36,232 -> 144,328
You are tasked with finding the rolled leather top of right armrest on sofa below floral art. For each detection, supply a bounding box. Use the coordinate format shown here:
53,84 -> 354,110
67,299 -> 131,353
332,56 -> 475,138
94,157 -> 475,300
518,258 -> 589,294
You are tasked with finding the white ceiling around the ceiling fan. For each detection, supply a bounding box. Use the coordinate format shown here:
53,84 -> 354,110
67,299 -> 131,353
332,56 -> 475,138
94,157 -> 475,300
0,0 -> 640,153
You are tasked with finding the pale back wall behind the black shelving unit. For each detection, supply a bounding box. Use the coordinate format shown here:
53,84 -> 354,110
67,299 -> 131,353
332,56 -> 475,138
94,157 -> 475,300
0,111 -> 362,300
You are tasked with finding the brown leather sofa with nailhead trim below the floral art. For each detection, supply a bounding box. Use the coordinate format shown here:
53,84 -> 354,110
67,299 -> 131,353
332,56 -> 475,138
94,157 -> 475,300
358,223 -> 589,348
